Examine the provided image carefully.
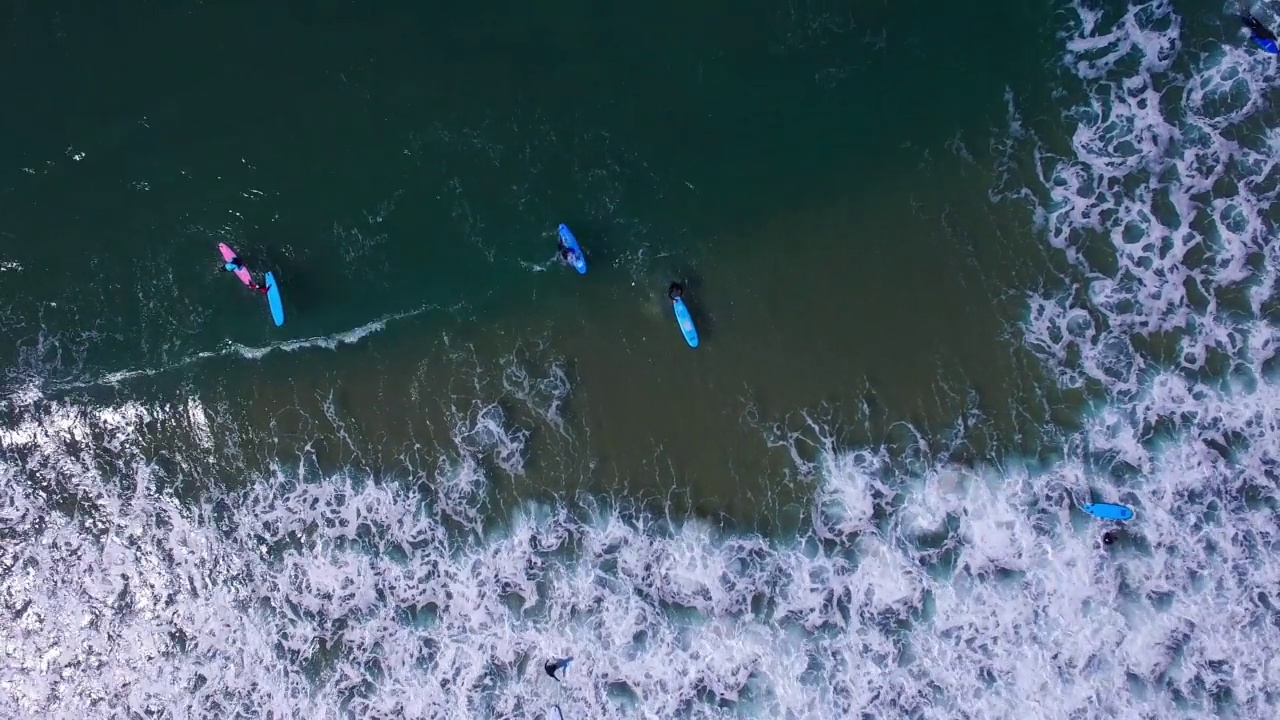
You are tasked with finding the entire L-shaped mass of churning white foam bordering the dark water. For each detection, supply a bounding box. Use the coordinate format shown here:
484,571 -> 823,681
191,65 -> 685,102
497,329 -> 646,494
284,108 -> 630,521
0,0 -> 1280,719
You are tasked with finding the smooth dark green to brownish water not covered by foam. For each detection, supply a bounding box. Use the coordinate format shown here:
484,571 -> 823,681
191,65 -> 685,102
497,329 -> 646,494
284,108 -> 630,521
0,1 -> 1060,523
